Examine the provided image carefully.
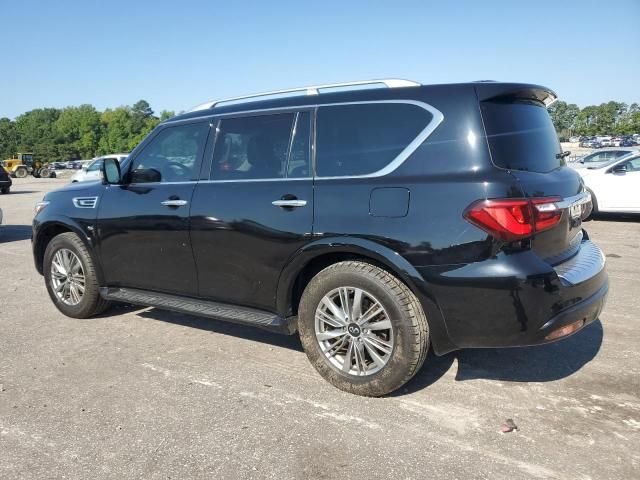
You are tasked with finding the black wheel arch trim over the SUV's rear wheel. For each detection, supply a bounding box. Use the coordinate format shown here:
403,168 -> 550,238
276,237 -> 457,355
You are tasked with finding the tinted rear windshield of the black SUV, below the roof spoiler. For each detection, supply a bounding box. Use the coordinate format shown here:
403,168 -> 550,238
480,102 -> 565,173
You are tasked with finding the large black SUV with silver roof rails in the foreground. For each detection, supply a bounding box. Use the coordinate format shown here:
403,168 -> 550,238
33,80 -> 608,395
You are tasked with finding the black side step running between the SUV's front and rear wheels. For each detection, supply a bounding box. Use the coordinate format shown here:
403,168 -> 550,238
100,287 -> 296,335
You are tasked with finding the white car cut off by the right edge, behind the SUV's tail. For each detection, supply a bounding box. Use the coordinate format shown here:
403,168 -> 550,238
578,153 -> 640,213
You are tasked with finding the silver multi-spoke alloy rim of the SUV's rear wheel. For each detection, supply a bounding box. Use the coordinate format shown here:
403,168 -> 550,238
315,287 -> 394,376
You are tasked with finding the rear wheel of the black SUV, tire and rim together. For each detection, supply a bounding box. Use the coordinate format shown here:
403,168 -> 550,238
298,261 -> 429,397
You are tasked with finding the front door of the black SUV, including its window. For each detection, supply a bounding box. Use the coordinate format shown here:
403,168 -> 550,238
97,120 -> 210,295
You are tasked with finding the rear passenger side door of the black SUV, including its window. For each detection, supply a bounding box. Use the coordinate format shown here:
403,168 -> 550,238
191,110 -> 313,311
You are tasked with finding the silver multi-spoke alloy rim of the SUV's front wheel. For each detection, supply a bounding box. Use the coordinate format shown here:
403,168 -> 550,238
51,248 -> 86,305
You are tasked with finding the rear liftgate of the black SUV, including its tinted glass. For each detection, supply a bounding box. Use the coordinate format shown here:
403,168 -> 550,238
480,97 -> 586,260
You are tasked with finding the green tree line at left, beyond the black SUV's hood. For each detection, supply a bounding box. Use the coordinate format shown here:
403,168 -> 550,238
0,100 -> 174,162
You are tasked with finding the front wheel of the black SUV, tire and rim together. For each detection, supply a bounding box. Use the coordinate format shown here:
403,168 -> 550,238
44,232 -> 109,318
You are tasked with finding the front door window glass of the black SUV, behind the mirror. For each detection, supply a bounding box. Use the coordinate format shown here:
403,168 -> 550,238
130,121 -> 209,183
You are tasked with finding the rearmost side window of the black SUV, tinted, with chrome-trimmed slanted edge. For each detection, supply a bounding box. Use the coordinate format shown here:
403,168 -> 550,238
316,103 -> 431,177
